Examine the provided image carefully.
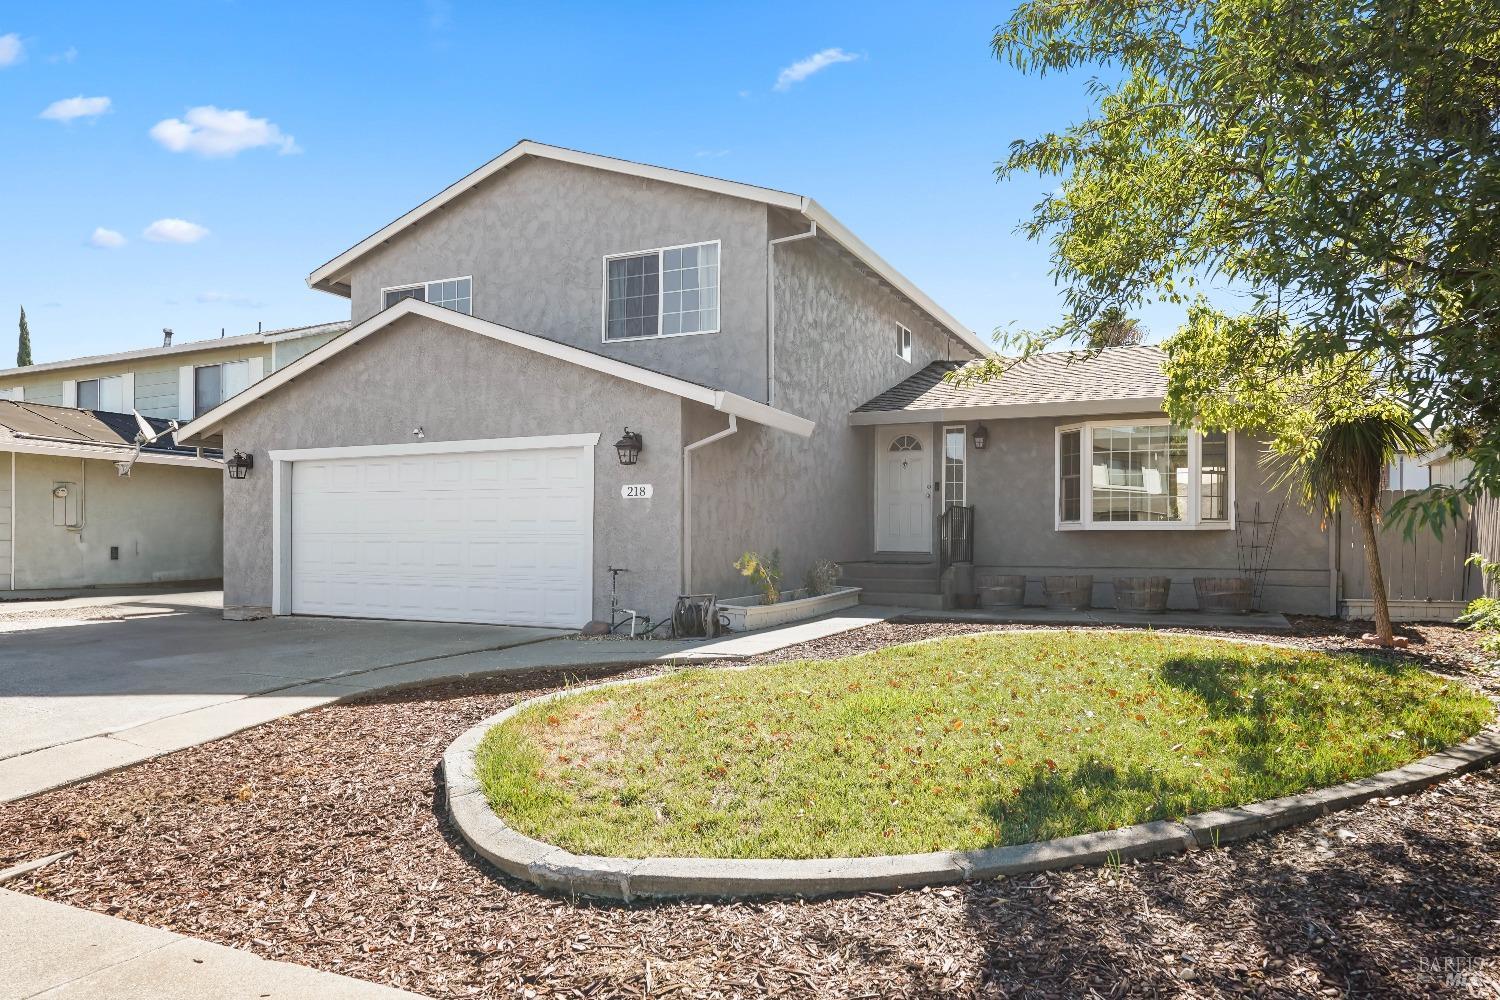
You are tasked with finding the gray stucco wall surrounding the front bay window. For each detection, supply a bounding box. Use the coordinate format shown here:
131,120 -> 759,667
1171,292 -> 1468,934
935,414 -> 1329,615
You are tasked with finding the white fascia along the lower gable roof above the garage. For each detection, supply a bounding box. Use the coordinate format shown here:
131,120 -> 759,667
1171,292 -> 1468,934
177,298 -> 818,441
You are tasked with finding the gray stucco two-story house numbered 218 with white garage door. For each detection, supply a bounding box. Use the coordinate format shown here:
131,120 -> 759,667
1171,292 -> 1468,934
175,141 -> 1328,627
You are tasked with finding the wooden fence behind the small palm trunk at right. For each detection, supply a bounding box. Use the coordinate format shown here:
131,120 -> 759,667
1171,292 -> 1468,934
1338,490 -> 1500,621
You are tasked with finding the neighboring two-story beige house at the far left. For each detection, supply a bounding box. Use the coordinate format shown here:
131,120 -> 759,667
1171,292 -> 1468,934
0,322 -> 348,595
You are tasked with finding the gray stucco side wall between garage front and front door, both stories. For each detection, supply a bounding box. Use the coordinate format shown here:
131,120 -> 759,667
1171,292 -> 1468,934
686,226 -> 969,595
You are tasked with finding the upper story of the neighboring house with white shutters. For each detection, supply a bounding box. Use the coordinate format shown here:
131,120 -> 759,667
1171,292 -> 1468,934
0,322 -> 350,421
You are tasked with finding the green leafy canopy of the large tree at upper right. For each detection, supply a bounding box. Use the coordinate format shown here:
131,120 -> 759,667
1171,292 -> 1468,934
990,0 -> 1500,509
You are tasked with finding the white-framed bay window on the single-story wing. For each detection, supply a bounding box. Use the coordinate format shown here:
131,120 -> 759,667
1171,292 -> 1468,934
1056,420 -> 1233,529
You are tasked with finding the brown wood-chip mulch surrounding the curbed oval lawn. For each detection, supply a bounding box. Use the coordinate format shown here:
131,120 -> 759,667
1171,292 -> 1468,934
0,619 -> 1500,999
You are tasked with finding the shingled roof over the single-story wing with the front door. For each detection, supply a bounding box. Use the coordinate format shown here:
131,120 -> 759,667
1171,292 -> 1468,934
849,345 -> 1167,424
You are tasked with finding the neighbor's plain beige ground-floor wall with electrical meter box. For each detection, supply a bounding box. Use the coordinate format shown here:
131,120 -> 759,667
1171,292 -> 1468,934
15,454 -> 224,589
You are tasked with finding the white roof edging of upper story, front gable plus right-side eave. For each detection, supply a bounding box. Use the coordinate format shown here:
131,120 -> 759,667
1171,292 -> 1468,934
308,139 -> 990,355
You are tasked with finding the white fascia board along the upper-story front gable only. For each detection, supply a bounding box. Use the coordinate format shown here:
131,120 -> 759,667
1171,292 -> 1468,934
308,139 -> 806,295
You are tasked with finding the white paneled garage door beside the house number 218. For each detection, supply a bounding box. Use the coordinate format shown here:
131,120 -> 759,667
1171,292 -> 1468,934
290,447 -> 594,628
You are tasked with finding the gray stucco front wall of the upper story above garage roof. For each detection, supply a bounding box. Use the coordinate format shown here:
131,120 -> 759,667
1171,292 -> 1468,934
339,159 -> 767,400
